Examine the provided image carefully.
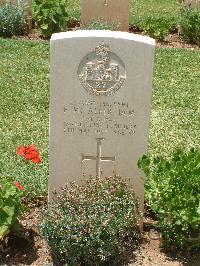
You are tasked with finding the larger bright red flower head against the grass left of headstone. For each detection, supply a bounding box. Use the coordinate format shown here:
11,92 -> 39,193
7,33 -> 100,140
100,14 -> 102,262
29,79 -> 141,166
17,145 -> 42,163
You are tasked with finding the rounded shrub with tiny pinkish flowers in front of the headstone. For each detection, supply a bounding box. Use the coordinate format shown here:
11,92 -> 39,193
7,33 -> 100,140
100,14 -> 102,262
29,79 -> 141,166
41,176 -> 140,265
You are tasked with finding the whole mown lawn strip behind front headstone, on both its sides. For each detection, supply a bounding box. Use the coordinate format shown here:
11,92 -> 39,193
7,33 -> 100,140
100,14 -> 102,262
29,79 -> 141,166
0,39 -> 200,196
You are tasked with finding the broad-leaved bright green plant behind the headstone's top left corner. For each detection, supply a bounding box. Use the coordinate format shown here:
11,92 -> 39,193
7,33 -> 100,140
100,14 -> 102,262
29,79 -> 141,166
32,0 -> 68,37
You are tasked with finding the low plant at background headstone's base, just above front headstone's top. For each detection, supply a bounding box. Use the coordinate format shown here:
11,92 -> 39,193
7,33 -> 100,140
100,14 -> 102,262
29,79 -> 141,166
80,18 -> 119,31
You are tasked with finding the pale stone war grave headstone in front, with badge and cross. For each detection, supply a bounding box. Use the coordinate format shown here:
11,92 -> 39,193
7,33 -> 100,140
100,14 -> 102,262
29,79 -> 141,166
49,31 -> 155,214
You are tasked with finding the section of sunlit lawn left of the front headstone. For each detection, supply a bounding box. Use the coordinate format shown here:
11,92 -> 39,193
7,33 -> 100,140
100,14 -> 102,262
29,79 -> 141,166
0,39 -> 49,195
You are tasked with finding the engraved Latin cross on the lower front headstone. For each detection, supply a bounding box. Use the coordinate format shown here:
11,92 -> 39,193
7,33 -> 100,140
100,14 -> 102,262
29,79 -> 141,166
82,138 -> 115,177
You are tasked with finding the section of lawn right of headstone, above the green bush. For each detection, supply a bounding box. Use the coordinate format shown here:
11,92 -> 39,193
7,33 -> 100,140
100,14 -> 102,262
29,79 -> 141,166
150,49 -> 200,155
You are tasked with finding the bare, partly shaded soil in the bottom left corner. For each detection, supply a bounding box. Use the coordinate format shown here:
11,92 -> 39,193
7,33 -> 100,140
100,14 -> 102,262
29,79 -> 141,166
0,203 -> 51,266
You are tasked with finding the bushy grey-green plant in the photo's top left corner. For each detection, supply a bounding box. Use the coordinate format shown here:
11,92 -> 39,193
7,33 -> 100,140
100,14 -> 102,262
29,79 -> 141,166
0,2 -> 26,37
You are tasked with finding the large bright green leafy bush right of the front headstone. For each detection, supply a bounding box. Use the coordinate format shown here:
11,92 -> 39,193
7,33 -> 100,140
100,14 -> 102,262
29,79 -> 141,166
139,149 -> 200,248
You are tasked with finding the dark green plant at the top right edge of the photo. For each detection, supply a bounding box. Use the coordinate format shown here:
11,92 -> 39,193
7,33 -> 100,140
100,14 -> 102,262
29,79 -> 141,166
180,8 -> 200,45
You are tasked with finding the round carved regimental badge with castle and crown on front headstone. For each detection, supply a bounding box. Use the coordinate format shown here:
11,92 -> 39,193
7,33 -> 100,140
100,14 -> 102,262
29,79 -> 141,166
78,42 -> 126,96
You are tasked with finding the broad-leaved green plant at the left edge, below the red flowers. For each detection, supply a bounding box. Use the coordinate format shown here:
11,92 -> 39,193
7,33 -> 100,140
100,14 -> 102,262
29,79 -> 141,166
0,177 -> 25,240
